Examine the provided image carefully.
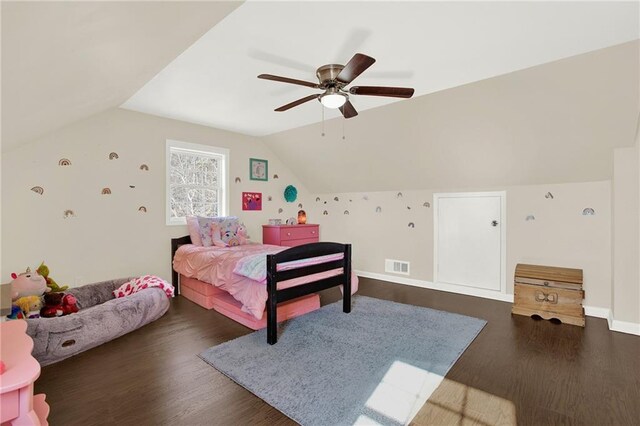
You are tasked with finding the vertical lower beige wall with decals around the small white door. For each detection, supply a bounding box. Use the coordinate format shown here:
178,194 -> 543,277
307,181 -> 611,308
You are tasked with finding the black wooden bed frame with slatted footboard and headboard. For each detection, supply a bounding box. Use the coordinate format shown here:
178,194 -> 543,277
171,235 -> 351,345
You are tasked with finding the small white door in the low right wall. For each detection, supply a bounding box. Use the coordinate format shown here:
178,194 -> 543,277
434,192 -> 504,291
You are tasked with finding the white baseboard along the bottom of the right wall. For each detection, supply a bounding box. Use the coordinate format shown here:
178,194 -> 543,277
354,270 -> 640,335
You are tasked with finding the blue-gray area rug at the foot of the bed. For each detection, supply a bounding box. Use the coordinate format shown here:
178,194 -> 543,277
200,296 -> 486,425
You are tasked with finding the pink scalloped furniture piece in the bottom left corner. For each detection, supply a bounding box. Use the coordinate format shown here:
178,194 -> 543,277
0,320 -> 49,426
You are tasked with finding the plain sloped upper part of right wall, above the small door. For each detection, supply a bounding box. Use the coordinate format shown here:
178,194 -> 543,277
265,41 -> 640,193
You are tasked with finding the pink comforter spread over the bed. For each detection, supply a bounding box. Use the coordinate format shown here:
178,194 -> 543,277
173,244 -> 358,320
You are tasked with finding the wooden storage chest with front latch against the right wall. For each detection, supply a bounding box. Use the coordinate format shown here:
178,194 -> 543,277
511,264 -> 585,327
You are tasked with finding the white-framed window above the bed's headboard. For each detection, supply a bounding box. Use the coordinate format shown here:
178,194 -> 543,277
167,140 -> 229,225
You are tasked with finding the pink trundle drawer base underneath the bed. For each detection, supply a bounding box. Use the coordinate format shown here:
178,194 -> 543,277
180,275 -> 320,330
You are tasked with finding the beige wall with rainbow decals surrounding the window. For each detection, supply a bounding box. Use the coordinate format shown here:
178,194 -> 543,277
0,109 -> 306,286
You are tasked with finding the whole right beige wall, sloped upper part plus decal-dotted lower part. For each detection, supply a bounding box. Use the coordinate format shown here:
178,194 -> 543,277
265,42 -> 639,308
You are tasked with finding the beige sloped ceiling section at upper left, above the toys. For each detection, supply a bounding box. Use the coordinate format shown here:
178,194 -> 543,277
0,1 -> 240,151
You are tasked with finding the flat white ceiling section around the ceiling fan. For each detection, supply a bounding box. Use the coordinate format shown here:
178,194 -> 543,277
122,2 -> 638,135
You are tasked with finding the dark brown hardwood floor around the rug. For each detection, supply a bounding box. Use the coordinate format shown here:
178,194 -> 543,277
35,278 -> 640,426
